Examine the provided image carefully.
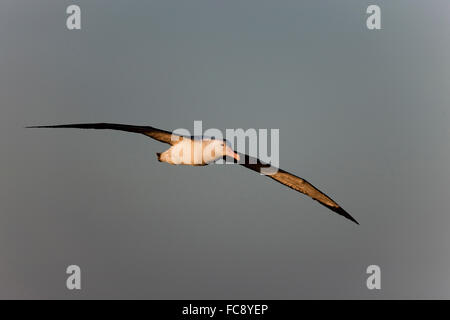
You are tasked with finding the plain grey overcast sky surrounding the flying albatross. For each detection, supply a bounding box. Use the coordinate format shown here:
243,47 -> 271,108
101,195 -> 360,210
0,0 -> 450,299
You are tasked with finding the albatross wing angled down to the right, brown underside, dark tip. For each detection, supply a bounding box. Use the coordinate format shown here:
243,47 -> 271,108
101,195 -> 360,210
239,154 -> 359,224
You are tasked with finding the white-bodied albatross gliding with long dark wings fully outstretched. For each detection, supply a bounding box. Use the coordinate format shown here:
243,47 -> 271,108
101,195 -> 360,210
27,123 -> 359,224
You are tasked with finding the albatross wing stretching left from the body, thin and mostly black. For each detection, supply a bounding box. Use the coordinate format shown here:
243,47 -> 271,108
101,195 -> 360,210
27,123 -> 183,145
